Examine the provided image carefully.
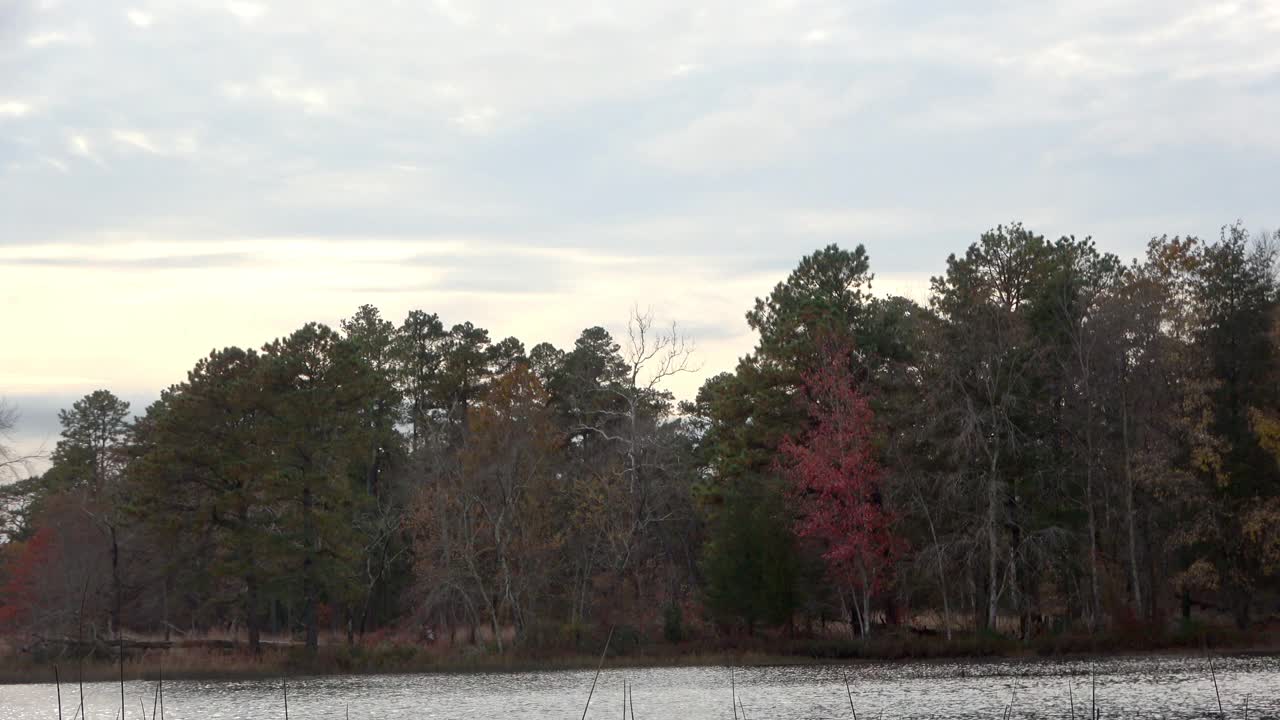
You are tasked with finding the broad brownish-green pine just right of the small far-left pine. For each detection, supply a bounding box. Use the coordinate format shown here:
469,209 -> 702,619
129,347 -> 277,652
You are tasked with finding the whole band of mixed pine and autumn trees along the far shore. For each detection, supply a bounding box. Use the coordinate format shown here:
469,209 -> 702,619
0,223 -> 1280,655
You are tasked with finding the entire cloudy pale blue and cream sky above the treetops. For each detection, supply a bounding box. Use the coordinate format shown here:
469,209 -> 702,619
0,0 -> 1280,468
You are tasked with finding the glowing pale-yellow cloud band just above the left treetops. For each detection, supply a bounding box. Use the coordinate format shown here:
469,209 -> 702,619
0,238 -> 778,397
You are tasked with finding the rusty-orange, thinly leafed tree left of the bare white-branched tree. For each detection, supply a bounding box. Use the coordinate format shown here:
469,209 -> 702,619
413,365 -> 564,651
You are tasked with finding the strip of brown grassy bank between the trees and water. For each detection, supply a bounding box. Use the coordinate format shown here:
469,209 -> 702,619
0,614 -> 1280,683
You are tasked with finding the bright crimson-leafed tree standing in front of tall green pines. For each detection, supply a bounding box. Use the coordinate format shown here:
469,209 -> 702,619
780,343 -> 902,635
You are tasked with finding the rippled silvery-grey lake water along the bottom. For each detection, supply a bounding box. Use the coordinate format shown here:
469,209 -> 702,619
0,657 -> 1280,720
